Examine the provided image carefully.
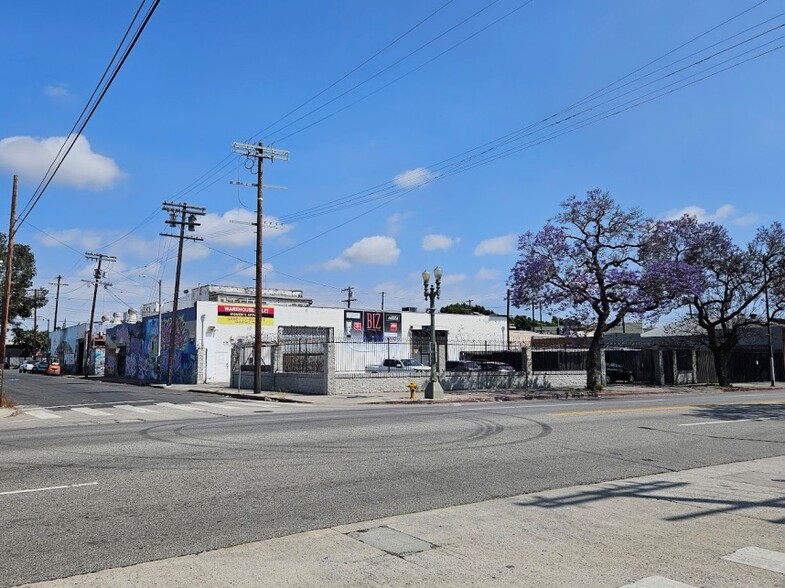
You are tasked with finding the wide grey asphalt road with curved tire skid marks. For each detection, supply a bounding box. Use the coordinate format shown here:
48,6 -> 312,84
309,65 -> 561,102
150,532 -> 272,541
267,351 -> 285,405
0,376 -> 785,586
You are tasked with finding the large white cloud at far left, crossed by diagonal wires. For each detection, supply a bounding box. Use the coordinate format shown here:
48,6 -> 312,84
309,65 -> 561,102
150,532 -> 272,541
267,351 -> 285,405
0,136 -> 125,190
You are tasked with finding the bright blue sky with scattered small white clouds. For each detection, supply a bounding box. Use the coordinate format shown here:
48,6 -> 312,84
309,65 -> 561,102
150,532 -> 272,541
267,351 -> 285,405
0,0 -> 785,324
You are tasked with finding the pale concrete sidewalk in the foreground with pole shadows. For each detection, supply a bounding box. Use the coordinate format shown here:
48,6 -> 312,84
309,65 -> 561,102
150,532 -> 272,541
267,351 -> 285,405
24,456 -> 785,588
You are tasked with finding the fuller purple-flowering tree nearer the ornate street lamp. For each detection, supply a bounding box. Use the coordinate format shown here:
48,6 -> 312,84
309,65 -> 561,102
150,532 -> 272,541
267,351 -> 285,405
508,189 -> 701,390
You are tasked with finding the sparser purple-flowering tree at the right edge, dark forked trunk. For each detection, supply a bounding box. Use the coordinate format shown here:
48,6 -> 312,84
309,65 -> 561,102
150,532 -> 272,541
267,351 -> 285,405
649,216 -> 785,386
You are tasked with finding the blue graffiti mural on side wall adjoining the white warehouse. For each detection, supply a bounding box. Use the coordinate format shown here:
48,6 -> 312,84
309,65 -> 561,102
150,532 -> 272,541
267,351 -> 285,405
106,308 -> 196,384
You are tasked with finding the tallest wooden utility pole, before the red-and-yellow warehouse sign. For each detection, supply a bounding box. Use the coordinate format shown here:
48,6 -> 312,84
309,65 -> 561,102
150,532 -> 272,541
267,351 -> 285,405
232,141 -> 289,394
